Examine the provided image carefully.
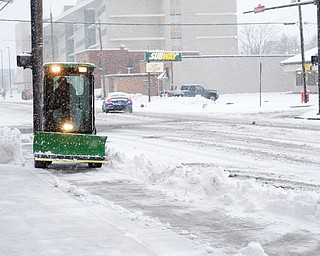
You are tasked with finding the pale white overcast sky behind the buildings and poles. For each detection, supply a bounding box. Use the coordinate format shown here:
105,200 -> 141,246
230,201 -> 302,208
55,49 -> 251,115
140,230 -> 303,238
0,0 -> 317,68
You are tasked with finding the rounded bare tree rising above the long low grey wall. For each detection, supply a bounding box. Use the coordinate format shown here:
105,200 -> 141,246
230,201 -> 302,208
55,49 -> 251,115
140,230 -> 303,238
239,24 -> 278,55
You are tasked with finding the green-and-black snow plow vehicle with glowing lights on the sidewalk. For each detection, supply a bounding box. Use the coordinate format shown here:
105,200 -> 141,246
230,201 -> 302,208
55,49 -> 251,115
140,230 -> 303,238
33,63 -> 107,168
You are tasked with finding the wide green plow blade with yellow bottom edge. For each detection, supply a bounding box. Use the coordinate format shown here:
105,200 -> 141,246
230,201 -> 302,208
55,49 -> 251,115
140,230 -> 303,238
33,132 -> 107,162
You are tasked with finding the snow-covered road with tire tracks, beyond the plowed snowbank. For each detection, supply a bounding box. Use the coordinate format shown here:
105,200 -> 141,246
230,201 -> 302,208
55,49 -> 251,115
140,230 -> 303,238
98,109 -> 320,185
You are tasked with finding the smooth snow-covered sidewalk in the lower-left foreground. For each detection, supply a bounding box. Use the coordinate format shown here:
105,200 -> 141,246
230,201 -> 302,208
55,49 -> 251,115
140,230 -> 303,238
0,165 -> 209,256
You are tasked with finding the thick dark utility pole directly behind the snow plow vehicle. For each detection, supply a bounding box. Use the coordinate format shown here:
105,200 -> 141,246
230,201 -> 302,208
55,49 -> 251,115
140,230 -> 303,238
30,0 -> 43,132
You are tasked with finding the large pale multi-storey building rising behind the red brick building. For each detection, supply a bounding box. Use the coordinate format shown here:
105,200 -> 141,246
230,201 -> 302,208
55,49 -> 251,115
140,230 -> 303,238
44,0 -> 238,61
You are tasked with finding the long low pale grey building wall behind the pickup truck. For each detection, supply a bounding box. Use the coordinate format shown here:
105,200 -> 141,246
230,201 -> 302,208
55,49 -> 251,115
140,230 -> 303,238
173,55 -> 295,94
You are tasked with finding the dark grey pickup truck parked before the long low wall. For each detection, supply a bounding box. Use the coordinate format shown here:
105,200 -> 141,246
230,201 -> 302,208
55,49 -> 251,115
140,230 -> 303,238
167,84 -> 219,100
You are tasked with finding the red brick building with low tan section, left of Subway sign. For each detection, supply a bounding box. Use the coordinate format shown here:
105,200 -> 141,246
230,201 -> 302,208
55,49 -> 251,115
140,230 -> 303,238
74,47 -> 170,96
